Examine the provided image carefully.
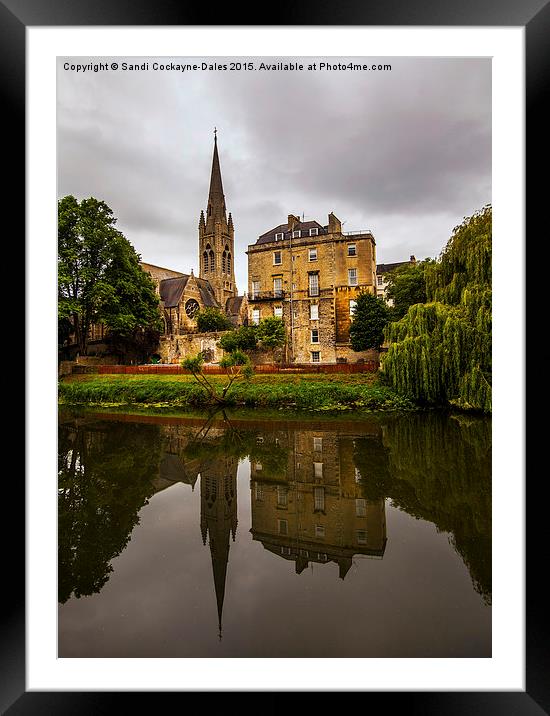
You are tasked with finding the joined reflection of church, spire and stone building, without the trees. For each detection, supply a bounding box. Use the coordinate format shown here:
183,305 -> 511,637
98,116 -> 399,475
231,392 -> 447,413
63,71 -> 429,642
162,422 -> 386,638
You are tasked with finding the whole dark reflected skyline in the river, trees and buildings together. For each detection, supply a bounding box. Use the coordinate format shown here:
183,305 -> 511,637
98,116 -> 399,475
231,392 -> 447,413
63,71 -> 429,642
58,415 -> 491,638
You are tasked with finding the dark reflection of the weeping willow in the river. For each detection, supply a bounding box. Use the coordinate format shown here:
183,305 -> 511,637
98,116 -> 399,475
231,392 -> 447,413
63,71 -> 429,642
354,412 -> 491,604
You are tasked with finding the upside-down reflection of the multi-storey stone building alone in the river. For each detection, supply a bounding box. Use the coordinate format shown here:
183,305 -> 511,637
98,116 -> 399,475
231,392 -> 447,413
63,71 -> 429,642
250,430 -> 386,579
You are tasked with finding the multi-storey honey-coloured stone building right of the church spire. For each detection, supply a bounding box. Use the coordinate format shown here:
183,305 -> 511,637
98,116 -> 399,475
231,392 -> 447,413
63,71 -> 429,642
247,213 -> 376,363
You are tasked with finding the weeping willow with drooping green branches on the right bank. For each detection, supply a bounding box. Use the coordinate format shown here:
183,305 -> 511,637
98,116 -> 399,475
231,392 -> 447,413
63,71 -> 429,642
383,206 -> 492,412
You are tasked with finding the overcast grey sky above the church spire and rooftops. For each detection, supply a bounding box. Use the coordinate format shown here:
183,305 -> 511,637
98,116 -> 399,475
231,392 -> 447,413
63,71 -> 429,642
57,57 -> 491,293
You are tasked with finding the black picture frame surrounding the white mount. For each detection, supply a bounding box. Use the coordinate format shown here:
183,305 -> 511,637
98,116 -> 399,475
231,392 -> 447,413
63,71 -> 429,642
7,0 -> 550,716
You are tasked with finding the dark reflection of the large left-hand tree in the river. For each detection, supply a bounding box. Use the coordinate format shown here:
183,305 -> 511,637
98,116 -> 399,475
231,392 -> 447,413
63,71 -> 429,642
58,419 -> 161,603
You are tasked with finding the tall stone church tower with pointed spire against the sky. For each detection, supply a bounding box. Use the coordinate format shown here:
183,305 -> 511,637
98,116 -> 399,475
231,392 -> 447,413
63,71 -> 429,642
199,130 -> 237,309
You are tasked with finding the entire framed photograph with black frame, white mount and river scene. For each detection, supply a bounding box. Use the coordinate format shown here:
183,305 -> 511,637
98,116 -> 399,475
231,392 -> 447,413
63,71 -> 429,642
8,2 -> 550,714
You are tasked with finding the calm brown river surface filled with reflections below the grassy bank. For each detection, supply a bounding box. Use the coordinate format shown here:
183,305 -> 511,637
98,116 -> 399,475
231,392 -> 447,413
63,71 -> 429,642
58,412 -> 491,657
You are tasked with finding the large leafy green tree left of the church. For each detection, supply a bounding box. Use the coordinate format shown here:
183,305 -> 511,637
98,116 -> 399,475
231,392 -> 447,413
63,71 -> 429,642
58,196 -> 161,355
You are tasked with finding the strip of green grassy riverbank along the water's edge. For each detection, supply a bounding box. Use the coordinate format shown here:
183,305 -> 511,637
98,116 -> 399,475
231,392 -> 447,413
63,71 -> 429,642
59,373 -> 415,412
